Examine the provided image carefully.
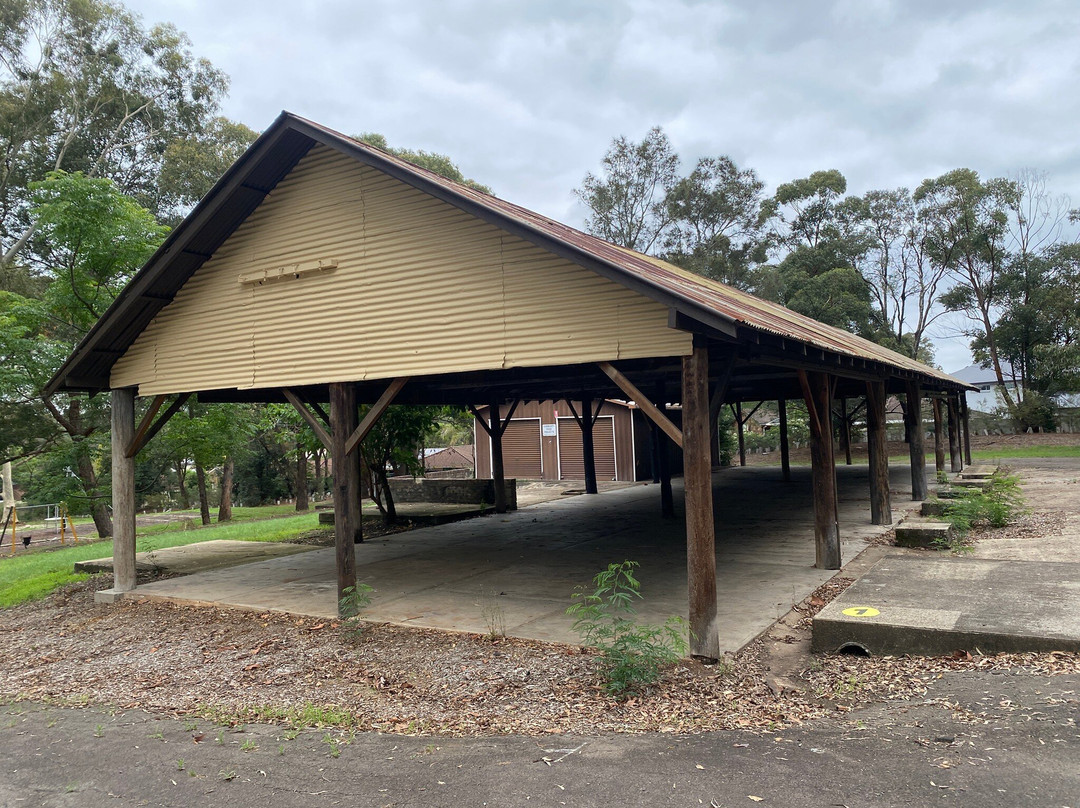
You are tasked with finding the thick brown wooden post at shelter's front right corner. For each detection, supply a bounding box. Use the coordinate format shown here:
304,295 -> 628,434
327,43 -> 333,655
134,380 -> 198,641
683,340 -> 720,660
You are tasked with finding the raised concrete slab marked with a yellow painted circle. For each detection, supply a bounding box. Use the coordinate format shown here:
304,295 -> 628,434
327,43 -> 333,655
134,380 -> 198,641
813,555 -> 1080,655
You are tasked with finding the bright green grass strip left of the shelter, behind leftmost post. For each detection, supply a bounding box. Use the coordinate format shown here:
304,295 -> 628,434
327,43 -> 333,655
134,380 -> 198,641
0,506 -> 318,608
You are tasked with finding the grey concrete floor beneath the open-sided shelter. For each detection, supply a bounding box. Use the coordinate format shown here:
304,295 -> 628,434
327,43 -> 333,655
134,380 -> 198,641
126,466 -> 917,650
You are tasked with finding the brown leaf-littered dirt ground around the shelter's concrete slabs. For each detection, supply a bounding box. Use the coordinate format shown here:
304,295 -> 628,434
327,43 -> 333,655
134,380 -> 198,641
0,453 -> 1080,736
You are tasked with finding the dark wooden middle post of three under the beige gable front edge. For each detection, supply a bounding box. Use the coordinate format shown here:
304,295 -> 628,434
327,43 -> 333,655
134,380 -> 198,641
329,382 -> 364,604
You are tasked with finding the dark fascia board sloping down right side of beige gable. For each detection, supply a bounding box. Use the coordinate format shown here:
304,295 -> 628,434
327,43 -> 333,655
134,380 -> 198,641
292,118 -> 737,337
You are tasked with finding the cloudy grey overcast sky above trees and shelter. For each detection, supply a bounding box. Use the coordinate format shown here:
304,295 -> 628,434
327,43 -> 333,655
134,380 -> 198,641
125,0 -> 1080,371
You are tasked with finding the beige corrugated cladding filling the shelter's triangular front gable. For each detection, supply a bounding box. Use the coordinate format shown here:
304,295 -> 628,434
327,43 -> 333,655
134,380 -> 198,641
110,146 -> 691,395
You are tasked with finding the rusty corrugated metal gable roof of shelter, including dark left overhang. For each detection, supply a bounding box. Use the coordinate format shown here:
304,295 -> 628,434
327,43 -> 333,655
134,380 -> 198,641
46,112 -> 968,392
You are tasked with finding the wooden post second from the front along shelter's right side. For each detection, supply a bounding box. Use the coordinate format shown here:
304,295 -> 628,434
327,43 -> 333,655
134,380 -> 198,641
798,371 -> 840,569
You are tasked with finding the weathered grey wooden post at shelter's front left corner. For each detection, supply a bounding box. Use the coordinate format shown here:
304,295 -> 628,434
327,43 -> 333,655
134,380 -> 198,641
111,388 -> 135,593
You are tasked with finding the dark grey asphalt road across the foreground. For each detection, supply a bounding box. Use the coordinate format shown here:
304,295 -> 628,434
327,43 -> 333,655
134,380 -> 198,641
0,672 -> 1080,808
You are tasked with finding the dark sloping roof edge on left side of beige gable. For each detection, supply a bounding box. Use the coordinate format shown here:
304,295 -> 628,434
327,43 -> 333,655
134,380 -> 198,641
44,112 -> 315,395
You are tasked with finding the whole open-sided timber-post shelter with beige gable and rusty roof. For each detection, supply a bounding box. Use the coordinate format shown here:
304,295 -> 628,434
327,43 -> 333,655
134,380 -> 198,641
48,113 -> 964,657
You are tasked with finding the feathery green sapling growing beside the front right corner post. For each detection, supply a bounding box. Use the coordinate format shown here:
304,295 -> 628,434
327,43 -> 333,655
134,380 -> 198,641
566,561 -> 687,697
